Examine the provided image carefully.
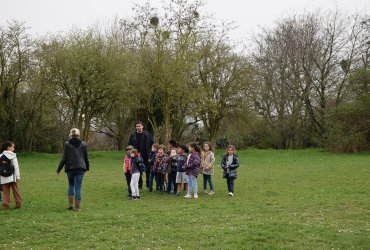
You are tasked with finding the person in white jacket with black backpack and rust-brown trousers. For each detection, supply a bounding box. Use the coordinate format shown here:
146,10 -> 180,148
0,141 -> 22,209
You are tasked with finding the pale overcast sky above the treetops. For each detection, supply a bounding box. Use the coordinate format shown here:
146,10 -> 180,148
0,0 -> 370,39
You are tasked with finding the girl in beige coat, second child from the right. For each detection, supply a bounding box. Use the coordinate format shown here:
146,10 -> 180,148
202,142 -> 215,195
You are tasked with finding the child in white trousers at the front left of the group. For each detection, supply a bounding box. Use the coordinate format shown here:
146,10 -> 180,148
130,149 -> 143,200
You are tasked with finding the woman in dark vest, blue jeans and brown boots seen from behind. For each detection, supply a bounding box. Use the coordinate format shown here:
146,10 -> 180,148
57,128 -> 89,211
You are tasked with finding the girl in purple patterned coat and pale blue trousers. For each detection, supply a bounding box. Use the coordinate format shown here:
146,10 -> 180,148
184,142 -> 201,199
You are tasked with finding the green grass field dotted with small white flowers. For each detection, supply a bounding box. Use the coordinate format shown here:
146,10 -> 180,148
0,149 -> 370,249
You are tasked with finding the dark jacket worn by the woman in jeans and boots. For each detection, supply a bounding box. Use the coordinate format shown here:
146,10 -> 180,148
57,138 -> 90,173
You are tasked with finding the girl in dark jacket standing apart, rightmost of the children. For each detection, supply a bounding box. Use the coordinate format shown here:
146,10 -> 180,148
221,145 -> 239,197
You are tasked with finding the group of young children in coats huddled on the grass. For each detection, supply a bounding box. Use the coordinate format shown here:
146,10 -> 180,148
123,140 -> 239,200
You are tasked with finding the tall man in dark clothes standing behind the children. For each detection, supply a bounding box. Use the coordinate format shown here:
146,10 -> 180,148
128,121 -> 153,189
